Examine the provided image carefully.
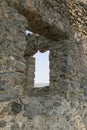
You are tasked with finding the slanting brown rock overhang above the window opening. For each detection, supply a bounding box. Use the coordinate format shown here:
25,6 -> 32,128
13,0 -> 68,40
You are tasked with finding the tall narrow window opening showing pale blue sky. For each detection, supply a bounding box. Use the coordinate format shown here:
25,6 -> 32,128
34,51 -> 50,87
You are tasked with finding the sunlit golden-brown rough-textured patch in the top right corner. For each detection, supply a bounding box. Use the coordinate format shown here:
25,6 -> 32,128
68,0 -> 87,38
